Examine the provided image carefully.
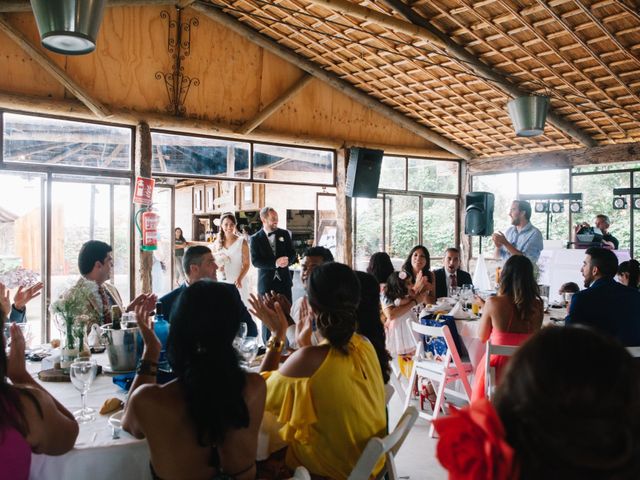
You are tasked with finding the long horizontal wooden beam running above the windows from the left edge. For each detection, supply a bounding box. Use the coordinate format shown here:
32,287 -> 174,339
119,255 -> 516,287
0,91 -> 460,160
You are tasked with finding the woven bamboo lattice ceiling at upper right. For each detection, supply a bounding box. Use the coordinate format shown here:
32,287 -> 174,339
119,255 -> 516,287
206,0 -> 640,156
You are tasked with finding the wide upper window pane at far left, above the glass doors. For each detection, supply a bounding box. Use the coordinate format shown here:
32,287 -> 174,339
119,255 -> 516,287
2,113 -> 132,170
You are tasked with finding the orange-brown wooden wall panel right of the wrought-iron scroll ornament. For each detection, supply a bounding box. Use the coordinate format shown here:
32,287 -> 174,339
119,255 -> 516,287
184,17 -> 262,125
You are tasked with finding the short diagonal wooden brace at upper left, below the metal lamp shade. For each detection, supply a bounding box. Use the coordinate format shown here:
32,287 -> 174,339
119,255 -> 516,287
0,14 -> 111,118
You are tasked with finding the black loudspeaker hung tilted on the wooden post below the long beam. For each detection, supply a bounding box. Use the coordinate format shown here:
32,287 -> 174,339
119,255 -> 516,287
346,148 -> 384,198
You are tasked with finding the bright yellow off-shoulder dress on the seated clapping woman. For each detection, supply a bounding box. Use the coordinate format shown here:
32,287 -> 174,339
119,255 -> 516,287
265,334 -> 387,479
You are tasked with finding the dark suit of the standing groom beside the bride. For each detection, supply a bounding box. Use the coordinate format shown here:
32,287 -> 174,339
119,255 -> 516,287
251,228 -> 296,302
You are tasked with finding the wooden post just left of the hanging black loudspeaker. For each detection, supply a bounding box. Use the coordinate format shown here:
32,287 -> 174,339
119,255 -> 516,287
336,148 -> 354,266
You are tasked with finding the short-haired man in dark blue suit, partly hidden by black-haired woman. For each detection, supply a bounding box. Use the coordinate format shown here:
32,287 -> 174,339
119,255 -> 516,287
159,245 -> 258,337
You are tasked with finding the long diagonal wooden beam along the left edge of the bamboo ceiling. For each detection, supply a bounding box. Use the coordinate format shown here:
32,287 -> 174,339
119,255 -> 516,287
193,3 -> 473,160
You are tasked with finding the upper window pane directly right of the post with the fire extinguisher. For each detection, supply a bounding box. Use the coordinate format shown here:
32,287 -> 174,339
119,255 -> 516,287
151,132 -> 249,178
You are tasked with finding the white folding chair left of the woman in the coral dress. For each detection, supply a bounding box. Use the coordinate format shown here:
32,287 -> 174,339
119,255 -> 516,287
404,322 -> 473,437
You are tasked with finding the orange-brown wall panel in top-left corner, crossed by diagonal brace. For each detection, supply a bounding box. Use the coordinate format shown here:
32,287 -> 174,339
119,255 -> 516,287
0,13 -> 65,98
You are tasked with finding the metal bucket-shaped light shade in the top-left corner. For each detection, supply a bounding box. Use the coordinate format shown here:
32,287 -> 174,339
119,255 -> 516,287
31,0 -> 107,55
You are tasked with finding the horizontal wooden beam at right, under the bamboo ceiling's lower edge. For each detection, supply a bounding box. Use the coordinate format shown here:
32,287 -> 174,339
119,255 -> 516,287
469,142 -> 640,174
